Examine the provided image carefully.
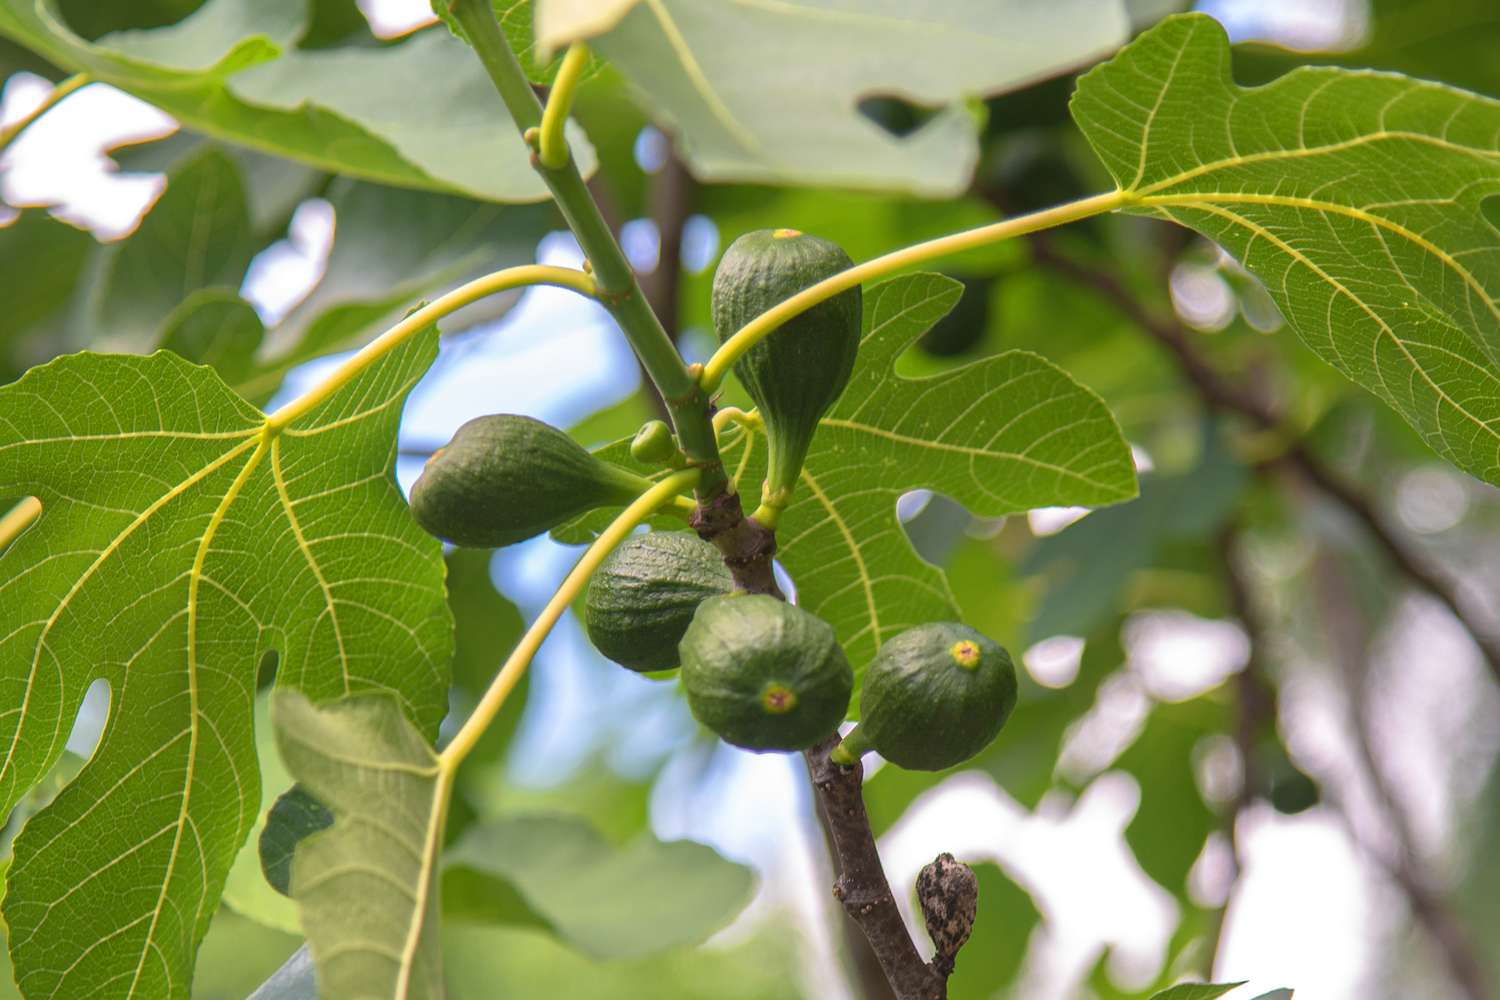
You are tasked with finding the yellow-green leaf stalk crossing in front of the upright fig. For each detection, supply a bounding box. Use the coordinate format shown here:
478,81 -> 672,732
698,190 -> 1128,393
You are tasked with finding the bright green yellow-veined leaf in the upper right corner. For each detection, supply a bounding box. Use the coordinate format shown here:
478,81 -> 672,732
1073,15 -> 1500,483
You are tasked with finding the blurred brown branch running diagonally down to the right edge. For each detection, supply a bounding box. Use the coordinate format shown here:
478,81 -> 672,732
1029,234 -> 1500,681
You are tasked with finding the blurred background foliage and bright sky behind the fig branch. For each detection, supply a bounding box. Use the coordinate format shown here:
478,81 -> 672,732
0,0 -> 1500,1000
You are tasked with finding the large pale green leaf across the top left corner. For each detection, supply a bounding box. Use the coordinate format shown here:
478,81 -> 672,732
0,0 -> 594,201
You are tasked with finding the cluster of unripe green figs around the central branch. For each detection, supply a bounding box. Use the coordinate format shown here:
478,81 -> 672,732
411,229 -> 1016,771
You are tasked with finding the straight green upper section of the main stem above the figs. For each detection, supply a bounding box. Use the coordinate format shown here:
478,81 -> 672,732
449,0 -> 728,499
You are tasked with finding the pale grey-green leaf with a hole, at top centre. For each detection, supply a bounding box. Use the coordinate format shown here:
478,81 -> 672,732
542,0 -> 1130,195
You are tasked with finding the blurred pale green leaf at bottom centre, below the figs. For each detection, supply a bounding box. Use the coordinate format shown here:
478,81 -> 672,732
443,816 -> 753,958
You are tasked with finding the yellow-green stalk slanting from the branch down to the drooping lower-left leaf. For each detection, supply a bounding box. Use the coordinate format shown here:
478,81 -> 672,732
438,469 -> 699,769
